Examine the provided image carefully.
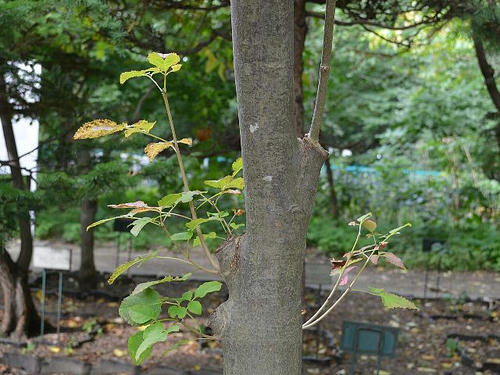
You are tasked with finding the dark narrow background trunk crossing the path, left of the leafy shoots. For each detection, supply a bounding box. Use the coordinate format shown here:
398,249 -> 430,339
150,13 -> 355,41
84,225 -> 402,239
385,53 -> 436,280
80,199 -> 97,290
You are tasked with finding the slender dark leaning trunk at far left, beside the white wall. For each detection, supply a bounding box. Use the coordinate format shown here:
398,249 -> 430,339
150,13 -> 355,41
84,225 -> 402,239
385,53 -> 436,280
0,71 -> 33,272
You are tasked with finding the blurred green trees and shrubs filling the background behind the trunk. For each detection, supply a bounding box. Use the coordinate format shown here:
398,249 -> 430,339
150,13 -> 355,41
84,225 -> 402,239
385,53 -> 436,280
0,0 -> 500,271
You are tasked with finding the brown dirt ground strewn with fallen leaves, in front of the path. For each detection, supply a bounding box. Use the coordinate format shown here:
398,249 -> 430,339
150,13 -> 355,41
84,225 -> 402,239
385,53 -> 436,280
0,276 -> 500,375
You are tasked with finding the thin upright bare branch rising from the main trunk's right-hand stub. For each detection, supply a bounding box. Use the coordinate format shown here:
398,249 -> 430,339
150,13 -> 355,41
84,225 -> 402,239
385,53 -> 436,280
309,0 -> 336,142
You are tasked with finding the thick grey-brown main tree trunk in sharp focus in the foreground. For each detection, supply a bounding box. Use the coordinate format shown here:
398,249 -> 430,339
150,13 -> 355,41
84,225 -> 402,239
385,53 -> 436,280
211,0 -> 327,375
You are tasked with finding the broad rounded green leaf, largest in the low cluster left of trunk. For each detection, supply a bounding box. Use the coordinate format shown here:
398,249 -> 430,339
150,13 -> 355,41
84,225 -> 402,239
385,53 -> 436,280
118,288 -> 161,324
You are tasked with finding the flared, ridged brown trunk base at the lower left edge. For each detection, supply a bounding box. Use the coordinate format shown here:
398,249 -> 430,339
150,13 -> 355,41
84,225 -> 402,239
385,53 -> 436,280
0,248 -> 40,338
